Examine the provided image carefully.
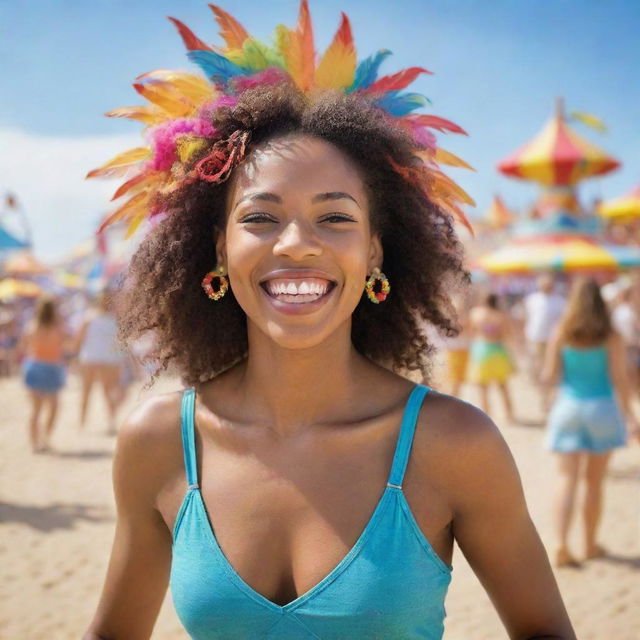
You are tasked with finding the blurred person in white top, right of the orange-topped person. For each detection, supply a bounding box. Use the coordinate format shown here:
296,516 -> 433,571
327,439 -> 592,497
76,291 -> 125,435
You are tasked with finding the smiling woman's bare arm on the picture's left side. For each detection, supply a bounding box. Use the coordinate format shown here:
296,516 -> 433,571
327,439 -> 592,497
83,399 -> 178,640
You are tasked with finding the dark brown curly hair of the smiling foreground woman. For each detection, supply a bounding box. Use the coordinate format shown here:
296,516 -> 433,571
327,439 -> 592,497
118,83 -> 471,385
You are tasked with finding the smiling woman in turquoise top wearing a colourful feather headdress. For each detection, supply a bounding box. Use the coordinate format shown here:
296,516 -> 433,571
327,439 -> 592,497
85,1 -> 575,640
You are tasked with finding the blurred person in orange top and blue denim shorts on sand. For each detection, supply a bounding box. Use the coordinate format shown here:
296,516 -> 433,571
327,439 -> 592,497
17,297 -> 68,453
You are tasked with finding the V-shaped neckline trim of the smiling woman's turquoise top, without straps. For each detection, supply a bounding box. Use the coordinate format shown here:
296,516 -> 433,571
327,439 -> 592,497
192,486 -> 397,613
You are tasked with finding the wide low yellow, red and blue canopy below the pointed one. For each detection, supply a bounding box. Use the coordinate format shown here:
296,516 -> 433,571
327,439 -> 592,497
478,235 -> 640,273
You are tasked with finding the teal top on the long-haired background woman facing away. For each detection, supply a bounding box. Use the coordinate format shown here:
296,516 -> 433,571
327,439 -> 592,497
560,345 -> 613,398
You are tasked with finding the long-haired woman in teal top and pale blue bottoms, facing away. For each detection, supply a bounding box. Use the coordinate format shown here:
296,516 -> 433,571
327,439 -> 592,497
542,278 -> 640,567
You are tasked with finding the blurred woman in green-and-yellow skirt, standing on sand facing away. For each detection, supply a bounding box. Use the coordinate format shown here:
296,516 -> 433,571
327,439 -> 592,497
469,293 -> 515,422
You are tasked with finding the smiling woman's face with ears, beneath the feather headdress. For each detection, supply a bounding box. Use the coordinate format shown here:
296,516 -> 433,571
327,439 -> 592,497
216,134 -> 382,348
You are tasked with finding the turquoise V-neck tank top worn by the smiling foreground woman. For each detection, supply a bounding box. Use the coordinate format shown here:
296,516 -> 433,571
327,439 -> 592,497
170,384 -> 453,640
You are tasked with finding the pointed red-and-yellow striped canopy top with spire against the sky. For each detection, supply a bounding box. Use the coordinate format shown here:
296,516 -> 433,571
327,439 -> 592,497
498,100 -> 620,186
